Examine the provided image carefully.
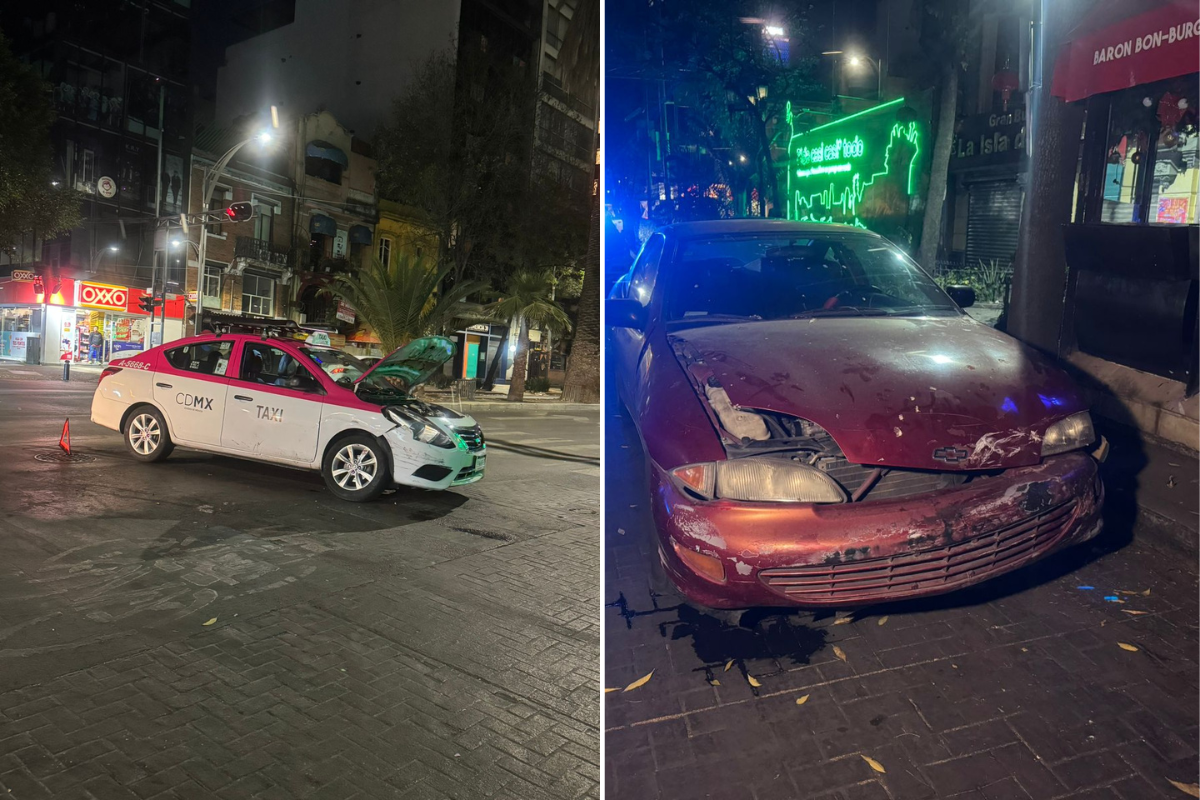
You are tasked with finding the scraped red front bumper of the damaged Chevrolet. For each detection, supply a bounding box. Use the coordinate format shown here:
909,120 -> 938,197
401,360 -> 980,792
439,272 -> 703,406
650,452 -> 1104,608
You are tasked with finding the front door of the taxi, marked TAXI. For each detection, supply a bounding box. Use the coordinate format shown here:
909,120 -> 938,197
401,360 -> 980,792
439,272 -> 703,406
221,341 -> 325,464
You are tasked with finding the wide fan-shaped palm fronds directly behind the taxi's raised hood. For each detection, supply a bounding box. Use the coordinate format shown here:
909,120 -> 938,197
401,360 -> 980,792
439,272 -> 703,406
329,253 -> 482,353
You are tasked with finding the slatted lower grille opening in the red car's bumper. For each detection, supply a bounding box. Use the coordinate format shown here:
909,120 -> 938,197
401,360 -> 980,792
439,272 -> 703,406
758,500 -> 1075,604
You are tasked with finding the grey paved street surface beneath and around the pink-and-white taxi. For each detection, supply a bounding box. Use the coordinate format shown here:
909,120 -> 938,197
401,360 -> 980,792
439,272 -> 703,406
0,381 -> 600,800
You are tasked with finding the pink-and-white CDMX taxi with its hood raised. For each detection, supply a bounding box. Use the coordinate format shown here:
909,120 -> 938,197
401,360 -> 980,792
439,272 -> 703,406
91,333 -> 487,501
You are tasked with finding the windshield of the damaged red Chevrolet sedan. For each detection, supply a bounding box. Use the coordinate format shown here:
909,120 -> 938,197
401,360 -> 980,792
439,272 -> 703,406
664,234 -> 961,324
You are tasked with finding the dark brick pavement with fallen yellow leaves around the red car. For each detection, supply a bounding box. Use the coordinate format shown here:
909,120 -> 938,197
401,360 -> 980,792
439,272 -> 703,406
604,393 -> 1198,800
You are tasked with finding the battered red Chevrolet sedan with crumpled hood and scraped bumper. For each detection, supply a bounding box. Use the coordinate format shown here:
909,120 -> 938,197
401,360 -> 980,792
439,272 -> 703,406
607,219 -> 1106,608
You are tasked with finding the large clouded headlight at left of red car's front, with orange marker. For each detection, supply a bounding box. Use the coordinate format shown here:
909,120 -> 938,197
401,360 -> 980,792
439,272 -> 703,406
671,458 -> 846,503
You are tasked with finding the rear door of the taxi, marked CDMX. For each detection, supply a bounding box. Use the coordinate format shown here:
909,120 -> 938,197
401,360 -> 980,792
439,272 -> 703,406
154,339 -> 234,447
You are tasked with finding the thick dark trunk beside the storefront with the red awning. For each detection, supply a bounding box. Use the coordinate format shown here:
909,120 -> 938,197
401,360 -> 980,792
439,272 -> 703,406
1007,0 -> 1088,354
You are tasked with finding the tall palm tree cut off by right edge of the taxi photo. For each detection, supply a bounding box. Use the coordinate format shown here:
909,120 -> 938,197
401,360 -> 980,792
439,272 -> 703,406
559,0 -> 600,403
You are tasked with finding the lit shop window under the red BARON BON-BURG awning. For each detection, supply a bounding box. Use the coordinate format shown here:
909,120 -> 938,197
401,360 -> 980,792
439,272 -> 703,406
1099,76 -> 1200,224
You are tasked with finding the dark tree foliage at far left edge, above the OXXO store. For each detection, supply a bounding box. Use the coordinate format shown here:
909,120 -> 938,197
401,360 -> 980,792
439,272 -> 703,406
0,35 -> 80,247
